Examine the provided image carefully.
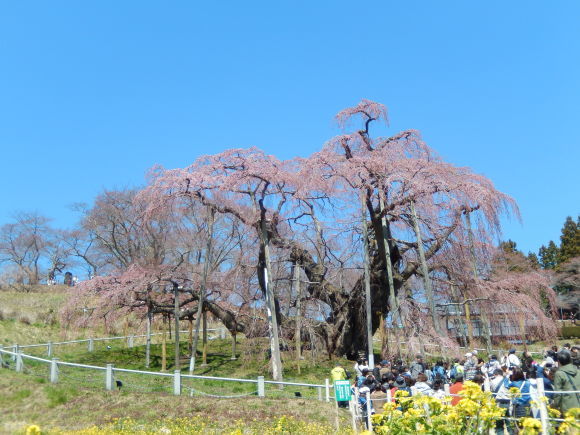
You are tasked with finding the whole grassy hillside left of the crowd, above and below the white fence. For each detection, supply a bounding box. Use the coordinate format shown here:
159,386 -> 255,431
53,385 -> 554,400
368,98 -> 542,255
0,287 -> 351,434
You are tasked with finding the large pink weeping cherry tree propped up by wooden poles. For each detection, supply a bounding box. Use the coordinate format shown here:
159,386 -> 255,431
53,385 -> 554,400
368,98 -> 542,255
63,100 -> 555,357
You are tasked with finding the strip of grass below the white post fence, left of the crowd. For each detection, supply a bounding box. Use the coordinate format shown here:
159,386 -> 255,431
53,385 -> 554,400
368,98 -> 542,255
0,370 -> 349,434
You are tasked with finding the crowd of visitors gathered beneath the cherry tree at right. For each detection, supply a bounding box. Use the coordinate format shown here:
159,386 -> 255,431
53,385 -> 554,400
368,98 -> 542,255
331,344 -> 580,418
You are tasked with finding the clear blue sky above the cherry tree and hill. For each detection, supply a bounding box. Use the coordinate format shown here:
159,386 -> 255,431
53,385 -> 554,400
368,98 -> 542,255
0,0 -> 580,252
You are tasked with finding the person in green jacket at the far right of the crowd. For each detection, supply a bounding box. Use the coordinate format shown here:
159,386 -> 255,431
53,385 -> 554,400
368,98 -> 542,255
554,346 -> 580,415
